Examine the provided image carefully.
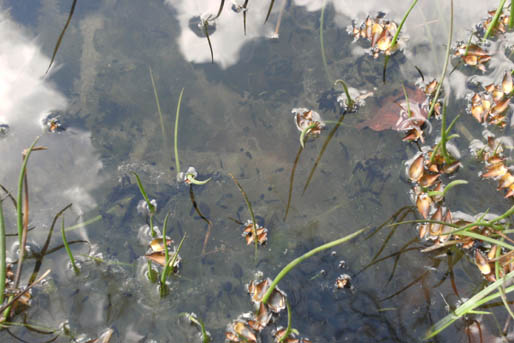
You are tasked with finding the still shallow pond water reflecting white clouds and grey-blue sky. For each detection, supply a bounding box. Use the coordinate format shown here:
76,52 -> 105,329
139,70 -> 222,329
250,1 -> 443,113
0,0 -> 514,342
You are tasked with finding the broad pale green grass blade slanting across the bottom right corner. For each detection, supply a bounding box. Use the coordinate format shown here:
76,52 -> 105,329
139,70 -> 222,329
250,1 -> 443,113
424,272 -> 514,340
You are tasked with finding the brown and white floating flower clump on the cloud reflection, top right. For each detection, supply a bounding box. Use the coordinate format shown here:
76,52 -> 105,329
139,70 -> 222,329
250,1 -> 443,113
348,13 -> 399,58
